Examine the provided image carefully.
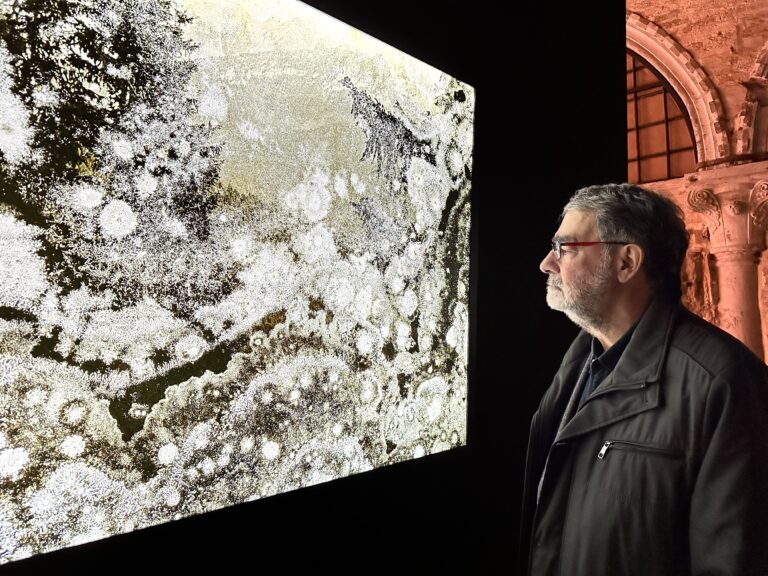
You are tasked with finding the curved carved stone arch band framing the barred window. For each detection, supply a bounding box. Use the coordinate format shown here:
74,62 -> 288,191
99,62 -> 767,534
627,11 -> 731,166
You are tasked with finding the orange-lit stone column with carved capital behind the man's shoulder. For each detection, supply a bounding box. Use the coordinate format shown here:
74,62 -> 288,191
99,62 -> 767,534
686,180 -> 768,358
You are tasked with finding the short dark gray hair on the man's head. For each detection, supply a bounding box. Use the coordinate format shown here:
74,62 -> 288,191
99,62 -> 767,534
561,184 -> 688,298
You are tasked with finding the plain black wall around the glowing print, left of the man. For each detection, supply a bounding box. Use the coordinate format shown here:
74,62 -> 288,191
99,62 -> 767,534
0,0 -> 626,575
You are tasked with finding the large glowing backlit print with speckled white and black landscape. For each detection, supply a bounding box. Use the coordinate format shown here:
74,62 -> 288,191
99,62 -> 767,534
0,0 -> 474,564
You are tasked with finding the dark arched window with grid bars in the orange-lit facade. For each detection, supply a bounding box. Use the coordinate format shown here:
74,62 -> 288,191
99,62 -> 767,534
627,51 -> 696,183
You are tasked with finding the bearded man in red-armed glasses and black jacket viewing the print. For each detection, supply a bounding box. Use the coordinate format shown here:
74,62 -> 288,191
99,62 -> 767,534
521,184 -> 768,576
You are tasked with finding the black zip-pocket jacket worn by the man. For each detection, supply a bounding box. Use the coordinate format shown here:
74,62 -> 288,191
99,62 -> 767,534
521,299 -> 768,576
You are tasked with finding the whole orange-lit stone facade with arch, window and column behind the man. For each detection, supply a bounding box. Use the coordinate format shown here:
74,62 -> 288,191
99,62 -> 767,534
626,0 -> 768,358
